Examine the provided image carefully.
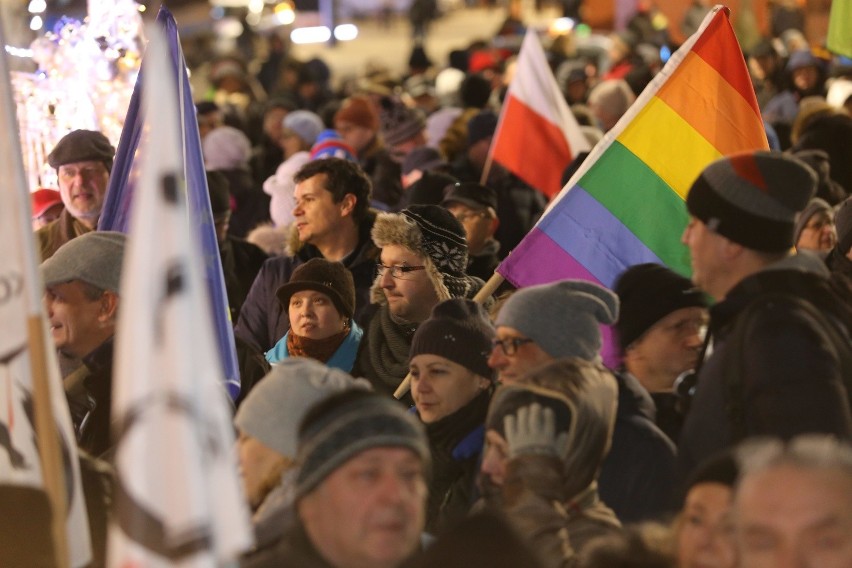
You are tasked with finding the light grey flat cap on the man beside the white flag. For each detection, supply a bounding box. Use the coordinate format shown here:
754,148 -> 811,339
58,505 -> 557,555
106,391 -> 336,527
41,231 -> 127,294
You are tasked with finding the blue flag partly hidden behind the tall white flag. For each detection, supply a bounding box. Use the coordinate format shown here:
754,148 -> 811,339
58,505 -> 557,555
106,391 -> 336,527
98,6 -> 240,399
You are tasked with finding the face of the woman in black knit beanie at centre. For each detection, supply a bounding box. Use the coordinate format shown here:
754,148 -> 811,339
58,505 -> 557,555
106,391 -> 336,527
409,353 -> 489,424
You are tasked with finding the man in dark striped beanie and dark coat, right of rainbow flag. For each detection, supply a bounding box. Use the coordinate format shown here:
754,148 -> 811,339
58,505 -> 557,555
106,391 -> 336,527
678,151 -> 852,476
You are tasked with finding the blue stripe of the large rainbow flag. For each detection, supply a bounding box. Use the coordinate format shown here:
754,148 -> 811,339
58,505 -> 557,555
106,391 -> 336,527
537,186 -> 665,288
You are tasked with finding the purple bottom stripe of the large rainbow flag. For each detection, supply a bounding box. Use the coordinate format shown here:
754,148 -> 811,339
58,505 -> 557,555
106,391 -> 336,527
497,228 -> 600,288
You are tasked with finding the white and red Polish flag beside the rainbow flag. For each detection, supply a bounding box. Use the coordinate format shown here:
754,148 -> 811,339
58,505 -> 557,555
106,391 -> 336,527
491,31 -> 589,197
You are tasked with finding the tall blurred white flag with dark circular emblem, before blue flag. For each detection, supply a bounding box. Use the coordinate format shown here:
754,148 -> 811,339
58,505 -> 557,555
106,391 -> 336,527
107,26 -> 252,568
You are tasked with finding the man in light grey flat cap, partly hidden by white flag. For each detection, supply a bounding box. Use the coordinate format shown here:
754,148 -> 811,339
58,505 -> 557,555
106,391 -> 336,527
41,231 -> 125,456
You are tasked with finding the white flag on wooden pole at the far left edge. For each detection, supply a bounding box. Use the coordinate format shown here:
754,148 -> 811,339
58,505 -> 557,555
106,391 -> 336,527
0,13 -> 91,566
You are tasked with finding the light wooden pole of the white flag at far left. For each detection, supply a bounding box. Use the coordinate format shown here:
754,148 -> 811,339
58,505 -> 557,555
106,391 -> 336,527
27,315 -> 69,568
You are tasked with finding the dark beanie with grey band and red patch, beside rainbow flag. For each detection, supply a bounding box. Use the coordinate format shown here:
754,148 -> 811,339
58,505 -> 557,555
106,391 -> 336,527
686,151 -> 817,252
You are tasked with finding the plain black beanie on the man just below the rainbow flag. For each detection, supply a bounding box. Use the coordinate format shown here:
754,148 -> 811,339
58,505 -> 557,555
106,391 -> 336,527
614,263 -> 707,351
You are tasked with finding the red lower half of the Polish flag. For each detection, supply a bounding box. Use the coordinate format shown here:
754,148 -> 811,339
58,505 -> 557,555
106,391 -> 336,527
491,95 -> 573,197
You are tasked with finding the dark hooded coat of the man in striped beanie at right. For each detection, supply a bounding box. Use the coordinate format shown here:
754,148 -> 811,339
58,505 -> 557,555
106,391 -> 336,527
678,254 -> 852,477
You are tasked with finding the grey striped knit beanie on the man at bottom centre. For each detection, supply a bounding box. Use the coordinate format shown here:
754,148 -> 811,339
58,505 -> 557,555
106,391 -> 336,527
296,391 -> 431,500
